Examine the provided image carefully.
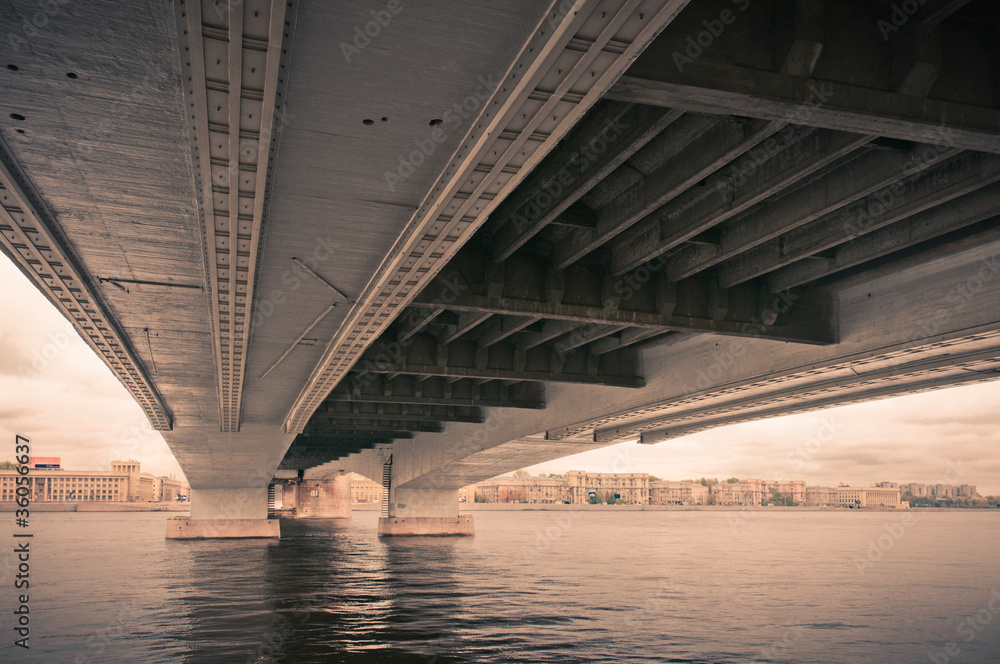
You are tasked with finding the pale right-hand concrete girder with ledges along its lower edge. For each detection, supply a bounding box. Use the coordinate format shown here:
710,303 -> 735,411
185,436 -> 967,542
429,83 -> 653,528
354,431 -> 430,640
358,232 -> 1000,498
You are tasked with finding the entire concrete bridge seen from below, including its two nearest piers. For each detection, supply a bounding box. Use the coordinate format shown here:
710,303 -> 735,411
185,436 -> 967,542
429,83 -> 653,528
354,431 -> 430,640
0,0 -> 1000,536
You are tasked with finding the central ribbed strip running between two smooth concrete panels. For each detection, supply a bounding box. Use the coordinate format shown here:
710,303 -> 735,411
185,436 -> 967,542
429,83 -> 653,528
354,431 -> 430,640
178,0 -> 291,432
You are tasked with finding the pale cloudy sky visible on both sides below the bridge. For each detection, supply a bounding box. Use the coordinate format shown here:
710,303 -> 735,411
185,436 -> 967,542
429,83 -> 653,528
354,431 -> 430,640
0,258 -> 1000,495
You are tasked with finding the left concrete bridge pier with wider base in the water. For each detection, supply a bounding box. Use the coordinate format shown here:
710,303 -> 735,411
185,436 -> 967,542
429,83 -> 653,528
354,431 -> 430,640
167,487 -> 281,539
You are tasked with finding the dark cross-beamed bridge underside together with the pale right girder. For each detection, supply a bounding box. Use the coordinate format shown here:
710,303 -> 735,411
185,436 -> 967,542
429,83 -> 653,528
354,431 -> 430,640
292,2 -> 1000,488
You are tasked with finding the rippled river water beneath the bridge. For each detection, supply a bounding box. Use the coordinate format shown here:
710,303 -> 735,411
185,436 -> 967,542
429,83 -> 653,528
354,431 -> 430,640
0,510 -> 1000,664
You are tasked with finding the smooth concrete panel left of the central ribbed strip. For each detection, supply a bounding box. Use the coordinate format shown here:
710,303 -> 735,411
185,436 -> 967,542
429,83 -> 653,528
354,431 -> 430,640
0,0 -> 218,440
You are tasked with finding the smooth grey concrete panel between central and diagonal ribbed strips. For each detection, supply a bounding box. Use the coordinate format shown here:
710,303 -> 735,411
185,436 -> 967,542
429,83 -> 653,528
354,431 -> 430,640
243,0 -> 546,430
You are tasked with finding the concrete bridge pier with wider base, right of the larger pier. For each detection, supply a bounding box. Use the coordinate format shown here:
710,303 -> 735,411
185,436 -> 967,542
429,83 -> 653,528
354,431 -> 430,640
378,488 -> 476,536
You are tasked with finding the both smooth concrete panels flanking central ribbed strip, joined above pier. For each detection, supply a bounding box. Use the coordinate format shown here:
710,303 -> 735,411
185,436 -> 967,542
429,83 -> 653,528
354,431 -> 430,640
0,0 -> 546,487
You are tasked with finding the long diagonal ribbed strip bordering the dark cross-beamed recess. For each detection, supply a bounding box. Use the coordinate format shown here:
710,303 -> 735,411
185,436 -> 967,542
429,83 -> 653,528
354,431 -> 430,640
284,0 -> 700,433
